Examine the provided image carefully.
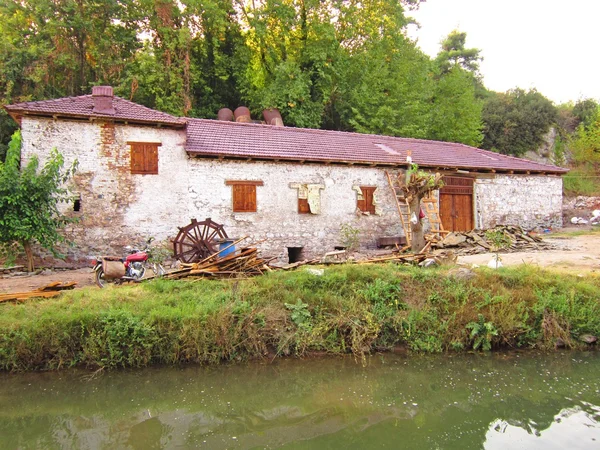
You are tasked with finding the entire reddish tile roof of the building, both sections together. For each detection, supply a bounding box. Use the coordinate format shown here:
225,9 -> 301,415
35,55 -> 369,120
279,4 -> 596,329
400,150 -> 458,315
5,91 -> 567,174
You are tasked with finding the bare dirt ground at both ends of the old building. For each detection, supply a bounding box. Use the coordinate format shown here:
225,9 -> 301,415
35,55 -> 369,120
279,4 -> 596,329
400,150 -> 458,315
0,228 -> 600,294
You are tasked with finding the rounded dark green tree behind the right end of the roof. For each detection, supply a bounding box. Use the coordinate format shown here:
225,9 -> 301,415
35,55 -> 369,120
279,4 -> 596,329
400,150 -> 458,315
482,89 -> 557,156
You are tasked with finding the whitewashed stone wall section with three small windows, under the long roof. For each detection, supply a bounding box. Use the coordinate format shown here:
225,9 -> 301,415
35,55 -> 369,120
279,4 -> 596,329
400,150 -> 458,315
189,159 -> 404,261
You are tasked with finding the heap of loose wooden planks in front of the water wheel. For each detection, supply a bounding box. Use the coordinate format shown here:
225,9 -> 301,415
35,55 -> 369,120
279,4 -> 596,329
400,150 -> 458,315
164,247 -> 271,279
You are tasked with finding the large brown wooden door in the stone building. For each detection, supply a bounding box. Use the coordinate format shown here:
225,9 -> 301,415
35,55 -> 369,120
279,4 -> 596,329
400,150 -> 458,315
440,176 -> 473,231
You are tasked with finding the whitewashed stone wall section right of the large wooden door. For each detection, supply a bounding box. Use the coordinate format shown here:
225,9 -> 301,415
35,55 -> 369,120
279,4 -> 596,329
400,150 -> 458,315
475,175 -> 562,229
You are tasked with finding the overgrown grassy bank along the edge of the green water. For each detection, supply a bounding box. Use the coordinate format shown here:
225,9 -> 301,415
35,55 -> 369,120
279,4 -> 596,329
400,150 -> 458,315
0,264 -> 600,370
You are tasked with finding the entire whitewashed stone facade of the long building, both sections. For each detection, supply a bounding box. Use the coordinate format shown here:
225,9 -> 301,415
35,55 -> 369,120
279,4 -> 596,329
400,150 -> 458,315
16,116 -> 562,265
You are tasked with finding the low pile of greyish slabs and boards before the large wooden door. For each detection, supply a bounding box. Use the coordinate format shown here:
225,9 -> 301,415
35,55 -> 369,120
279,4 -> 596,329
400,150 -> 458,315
430,225 -> 552,255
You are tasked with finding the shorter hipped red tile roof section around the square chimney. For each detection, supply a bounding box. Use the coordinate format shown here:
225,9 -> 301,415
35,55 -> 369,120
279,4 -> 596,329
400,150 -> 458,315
5,95 -> 185,127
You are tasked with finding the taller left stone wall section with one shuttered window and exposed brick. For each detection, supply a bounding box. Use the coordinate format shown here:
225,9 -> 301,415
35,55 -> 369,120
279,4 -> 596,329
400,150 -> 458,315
21,116 -> 188,264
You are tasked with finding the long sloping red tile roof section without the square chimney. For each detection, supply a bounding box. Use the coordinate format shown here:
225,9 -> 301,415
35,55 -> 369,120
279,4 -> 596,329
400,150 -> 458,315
186,119 -> 568,174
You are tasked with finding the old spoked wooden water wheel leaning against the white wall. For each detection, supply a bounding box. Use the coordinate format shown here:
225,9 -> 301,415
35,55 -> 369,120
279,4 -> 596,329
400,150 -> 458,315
173,217 -> 228,263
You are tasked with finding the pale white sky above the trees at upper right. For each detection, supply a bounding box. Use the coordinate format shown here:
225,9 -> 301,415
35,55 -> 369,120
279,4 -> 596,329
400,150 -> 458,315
408,0 -> 600,104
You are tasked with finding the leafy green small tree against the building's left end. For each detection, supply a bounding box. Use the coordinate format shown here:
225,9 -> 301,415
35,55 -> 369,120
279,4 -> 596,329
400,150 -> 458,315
0,131 -> 76,272
